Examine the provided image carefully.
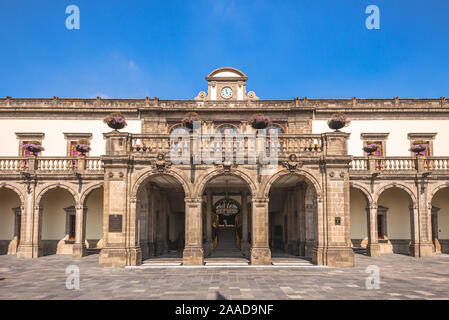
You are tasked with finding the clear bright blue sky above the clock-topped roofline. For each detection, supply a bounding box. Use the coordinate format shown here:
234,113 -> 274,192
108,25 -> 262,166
0,0 -> 449,99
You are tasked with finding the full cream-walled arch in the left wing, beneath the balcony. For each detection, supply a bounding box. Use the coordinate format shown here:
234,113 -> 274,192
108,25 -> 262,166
39,187 -> 76,255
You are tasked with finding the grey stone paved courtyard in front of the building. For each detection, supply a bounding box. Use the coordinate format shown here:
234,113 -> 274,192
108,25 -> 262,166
0,254 -> 449,300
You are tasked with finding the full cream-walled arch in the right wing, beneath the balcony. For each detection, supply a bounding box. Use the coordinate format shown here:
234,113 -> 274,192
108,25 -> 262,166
377,186 -> 414,255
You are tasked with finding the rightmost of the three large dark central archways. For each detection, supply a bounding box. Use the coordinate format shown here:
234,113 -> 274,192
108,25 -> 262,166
268,174 -> 317,259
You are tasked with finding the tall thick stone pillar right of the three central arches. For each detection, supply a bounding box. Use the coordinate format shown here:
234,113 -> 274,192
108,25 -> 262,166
312,132 -> 354,267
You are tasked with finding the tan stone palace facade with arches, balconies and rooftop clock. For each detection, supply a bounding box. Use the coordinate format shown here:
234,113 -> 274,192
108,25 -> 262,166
0,68 -> 449,267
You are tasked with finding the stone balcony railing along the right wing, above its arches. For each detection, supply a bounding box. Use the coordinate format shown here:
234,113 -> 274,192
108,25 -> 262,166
350,156 -> 449,173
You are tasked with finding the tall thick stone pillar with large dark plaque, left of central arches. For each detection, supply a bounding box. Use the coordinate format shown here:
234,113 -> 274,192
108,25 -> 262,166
99,131 -> 142,267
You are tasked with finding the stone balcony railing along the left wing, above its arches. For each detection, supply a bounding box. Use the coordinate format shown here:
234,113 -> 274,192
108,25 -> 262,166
0,157 -> 103,173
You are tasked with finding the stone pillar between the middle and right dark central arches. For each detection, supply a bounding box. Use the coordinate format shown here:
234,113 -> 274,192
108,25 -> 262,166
251,198 -> 271,265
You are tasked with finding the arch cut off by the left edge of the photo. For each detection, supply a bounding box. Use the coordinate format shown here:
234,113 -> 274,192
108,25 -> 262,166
0,188 -> 22,254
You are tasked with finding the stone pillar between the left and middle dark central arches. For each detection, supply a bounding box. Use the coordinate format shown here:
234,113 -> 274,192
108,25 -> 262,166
182,198 -> 204,265
